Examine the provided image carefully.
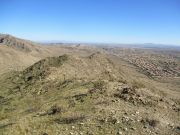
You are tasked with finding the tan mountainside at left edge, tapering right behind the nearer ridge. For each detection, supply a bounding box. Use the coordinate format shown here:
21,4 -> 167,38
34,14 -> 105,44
0,34 -> 98,74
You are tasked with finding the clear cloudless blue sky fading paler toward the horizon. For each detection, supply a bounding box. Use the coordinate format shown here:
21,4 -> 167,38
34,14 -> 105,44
0,0 -> 180,45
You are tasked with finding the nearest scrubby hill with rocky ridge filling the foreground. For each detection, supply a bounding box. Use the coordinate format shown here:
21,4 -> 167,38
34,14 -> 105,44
0,53 -> 180,135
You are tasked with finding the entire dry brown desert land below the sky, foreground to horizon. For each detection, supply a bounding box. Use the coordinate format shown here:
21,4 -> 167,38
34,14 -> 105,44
0,34 -> 180,135
